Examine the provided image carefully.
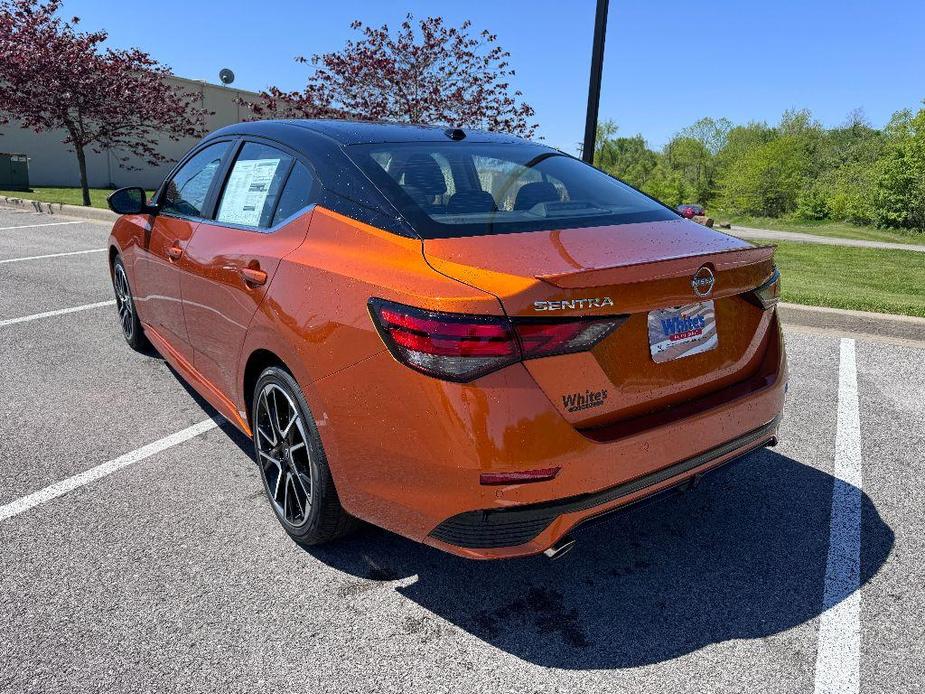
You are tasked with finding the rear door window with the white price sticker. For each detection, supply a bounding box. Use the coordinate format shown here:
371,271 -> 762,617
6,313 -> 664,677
215,142 -> 293,229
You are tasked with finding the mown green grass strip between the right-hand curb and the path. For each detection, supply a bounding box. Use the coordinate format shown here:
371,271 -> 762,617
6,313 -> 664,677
756,241 -> 925,317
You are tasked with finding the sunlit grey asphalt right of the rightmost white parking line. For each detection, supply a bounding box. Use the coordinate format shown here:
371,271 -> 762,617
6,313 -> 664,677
857,342 -> 925,694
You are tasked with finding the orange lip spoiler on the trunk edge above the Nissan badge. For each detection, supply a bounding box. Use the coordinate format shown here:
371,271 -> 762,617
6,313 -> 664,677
535,246 -> 776,289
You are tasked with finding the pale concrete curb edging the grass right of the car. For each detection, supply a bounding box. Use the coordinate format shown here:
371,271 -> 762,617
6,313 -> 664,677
777,303 -> 925,342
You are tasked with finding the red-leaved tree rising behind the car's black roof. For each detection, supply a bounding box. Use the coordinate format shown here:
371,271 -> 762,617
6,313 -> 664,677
250,14 -> 537,137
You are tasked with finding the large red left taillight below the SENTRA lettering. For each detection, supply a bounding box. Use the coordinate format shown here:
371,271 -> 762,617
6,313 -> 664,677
369,298 -> 626,382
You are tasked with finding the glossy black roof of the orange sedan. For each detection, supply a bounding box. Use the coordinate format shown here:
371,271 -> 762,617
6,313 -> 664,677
210,119 -> 525,145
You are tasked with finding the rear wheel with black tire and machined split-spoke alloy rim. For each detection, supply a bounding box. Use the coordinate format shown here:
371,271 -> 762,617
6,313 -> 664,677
251,366 -> 356,545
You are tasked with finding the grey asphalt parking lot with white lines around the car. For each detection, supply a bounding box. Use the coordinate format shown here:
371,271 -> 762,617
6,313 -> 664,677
0,208 -> 925,694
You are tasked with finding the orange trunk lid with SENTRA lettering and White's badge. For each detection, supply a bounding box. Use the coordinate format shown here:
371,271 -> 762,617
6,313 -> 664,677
424,220 -> 773,428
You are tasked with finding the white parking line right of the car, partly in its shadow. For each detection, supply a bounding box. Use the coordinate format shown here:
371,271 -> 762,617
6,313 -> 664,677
815,338 -> 862,694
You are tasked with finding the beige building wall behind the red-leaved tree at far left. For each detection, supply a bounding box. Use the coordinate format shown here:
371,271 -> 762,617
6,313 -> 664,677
0,77 -> 256,189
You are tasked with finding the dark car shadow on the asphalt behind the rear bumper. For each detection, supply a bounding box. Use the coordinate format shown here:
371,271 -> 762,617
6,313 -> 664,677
306,449 -> 894,669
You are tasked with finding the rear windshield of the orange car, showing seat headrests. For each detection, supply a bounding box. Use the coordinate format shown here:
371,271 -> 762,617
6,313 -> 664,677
347,142 -> 677,238
